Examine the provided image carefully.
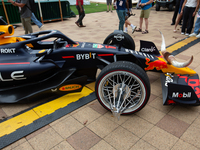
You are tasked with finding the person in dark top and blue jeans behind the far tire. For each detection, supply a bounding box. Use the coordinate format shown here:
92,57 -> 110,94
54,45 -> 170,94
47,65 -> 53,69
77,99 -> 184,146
113,0 -> 129,31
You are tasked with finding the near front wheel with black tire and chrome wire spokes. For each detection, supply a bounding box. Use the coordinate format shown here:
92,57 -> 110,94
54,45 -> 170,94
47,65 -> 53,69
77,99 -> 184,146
95,61 -> 150,114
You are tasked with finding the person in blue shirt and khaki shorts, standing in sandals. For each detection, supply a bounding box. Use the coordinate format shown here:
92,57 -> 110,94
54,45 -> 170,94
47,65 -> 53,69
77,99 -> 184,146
135,0 -> 153,34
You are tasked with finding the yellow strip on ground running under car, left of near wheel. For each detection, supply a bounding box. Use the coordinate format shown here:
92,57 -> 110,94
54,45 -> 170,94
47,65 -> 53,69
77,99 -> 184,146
0,87 -> 93,137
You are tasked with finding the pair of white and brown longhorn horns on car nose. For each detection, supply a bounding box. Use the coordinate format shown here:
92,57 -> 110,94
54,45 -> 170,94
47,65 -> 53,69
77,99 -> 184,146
160,32 -> 193,68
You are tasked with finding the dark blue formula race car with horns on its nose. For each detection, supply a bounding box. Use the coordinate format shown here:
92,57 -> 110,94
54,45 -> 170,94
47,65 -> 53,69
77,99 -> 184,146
0,17 -> 200,116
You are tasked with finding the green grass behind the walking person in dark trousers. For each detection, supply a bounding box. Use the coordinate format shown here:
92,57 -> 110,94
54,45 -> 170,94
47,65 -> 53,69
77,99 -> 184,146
70,3 -> 107,15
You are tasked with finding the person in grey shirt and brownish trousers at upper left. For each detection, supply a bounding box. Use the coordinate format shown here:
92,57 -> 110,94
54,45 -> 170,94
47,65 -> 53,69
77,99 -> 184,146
8,0 -> 33,34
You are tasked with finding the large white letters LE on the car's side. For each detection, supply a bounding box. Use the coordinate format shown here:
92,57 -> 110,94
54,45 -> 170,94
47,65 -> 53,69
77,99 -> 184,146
0,70 -> 26,81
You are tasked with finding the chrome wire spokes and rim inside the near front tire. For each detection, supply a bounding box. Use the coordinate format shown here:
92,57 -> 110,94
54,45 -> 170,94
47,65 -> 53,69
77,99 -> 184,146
102,72 -> 144,113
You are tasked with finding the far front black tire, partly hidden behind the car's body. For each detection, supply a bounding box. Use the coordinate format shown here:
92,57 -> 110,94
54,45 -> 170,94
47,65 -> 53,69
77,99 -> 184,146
103,32 -> 135,50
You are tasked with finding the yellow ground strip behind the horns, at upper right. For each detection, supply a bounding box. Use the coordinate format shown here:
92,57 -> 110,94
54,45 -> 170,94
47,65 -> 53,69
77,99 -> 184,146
166,37 -> 197,53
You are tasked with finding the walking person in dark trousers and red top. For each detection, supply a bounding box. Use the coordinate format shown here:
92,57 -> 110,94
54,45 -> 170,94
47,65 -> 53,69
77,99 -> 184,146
75,0 -> 86,27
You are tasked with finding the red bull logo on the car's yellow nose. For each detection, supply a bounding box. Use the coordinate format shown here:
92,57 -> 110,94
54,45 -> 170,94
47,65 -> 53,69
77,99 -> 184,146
144,58 -> 168,70
